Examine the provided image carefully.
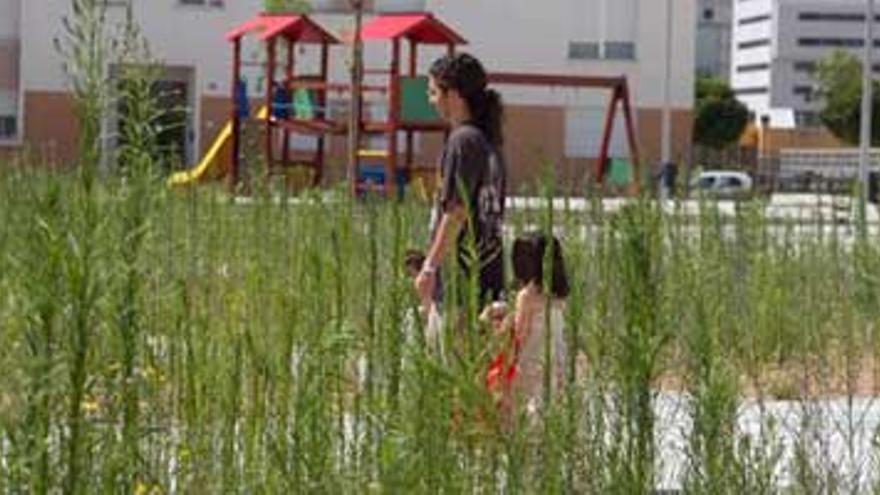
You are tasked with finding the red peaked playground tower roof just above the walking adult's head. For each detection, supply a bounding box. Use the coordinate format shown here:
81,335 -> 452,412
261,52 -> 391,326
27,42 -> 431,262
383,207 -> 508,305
361,14 -> 467,45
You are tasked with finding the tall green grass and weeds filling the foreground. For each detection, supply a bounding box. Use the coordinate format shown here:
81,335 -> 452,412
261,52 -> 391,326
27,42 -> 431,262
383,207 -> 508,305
0,0 -> 880,494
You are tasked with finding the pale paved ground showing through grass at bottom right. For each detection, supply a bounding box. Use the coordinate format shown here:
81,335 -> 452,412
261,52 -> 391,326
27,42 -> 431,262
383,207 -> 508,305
654,393 -> 880,493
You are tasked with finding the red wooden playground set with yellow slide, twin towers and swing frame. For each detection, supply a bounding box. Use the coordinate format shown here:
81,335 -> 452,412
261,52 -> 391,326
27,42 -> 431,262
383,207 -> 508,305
169,13 -> 639,196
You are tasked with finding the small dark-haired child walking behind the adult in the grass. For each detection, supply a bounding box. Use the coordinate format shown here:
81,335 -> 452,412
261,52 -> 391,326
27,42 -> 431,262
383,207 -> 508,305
484,232 -> 569,414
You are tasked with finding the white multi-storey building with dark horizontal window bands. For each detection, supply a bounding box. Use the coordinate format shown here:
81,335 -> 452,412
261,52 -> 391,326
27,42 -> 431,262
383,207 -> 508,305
731,0 -> 880,127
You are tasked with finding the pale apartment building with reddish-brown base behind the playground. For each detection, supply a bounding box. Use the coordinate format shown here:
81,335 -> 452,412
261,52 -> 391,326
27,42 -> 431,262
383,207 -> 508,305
0,0 -> 696,190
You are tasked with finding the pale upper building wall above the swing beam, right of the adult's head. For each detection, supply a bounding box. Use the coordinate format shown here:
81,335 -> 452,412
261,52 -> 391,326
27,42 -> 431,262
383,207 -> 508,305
428,0 -> 697,109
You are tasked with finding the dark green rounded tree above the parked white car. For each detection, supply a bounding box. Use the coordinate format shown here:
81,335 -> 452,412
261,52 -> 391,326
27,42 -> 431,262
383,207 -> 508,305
694,77 -> 749,149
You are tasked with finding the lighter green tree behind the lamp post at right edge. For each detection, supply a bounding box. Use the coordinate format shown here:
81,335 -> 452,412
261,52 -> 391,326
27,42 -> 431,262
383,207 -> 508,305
816,51 -> 880,146
